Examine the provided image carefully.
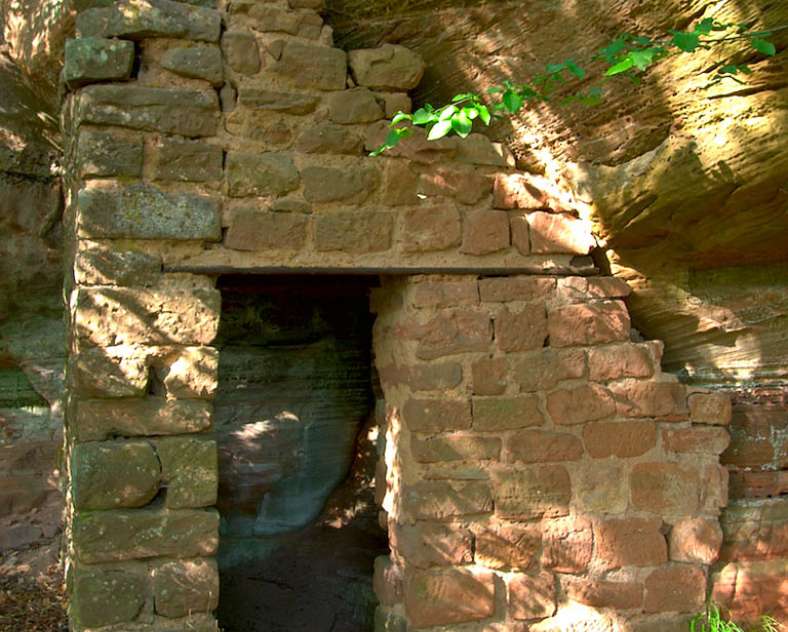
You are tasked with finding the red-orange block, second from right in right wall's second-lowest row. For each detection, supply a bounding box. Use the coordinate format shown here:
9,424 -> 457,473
594,518 -> 668,570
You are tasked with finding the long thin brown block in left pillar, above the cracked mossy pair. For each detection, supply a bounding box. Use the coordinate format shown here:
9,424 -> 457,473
73,398 -> 212,441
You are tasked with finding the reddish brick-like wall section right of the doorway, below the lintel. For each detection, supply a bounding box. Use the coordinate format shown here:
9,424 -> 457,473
374,276 -> 730,632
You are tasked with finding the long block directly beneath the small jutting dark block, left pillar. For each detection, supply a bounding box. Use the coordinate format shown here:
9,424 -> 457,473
77,84 -> 219,137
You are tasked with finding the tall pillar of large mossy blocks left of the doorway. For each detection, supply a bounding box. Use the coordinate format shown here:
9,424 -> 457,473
63,0 -> 222,632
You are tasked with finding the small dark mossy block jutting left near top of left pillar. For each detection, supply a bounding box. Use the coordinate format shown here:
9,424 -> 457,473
63,37 -> 134,87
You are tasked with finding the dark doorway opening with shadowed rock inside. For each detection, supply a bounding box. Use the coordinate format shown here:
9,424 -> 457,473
214,276 -> 388,632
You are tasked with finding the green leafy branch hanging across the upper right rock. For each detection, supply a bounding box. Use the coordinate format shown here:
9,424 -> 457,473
370,18 -> 788,156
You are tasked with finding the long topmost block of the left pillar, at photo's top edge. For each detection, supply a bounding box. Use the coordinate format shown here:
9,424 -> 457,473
77,0 -> 221,42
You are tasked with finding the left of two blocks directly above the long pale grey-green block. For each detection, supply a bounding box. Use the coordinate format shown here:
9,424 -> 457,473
77,130 -> 143,177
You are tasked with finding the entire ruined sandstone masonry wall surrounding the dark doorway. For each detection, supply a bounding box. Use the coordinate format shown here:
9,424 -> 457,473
63,0 -> 730,632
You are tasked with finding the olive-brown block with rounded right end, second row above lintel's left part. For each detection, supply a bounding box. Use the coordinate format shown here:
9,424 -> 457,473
227,151 -> 300,197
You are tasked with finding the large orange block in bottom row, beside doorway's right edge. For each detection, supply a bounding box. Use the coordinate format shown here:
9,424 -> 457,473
405,569 -> 495,628
